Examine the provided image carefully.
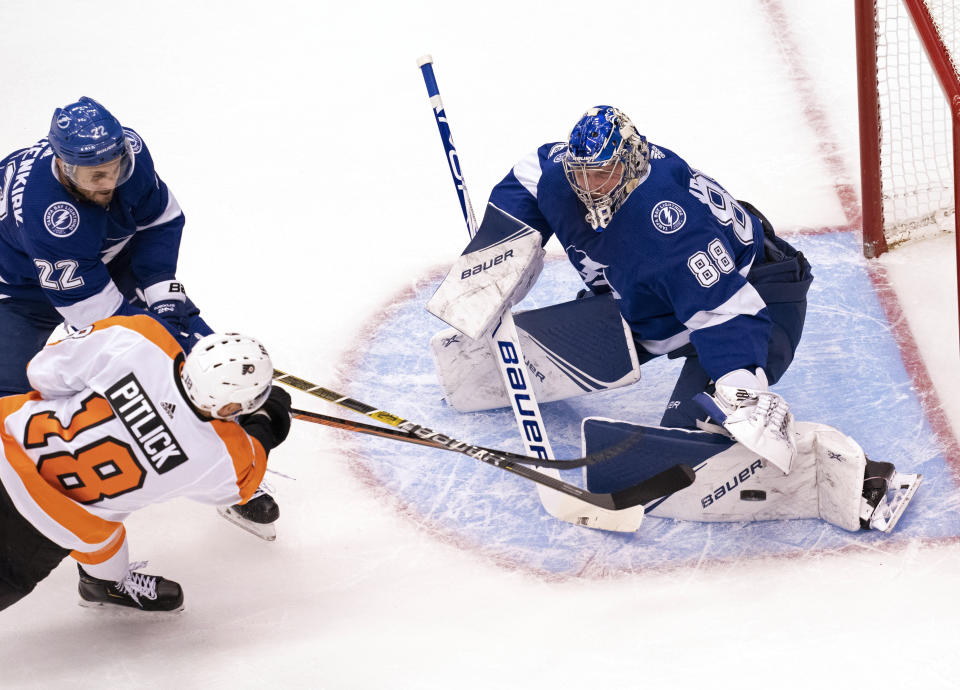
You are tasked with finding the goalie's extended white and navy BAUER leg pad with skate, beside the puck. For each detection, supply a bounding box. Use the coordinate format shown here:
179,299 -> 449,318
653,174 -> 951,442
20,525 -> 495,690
583,417 -> 922,532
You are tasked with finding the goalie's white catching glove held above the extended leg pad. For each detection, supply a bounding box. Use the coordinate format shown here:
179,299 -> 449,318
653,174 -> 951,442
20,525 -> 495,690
697,369 -> 797,474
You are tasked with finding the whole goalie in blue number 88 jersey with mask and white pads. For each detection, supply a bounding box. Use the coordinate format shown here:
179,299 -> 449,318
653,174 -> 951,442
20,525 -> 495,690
427,106 -> 922,531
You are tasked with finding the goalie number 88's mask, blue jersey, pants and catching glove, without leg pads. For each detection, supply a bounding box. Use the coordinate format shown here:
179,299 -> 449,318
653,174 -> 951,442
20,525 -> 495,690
456,106 -> 812,465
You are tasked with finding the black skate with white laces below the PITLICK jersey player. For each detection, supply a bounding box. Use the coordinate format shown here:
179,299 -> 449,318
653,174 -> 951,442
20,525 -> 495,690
77,561 -> 183,613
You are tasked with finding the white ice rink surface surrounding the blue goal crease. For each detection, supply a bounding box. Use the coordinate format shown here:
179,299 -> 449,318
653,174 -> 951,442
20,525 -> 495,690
0,0 -> 960,689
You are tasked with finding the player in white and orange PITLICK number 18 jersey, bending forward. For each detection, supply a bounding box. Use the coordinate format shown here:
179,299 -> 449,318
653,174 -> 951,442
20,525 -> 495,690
0,315 -> 290,611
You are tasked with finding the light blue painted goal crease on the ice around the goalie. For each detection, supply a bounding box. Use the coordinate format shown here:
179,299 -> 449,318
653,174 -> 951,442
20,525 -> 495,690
342,232 -> 960,576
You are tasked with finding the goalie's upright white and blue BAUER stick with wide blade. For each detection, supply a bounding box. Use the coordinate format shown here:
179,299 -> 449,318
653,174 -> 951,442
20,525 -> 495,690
417,60 -> 643,532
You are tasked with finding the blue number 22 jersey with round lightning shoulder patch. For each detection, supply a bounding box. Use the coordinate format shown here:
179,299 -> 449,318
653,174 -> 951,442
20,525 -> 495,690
0,128 -> 184,327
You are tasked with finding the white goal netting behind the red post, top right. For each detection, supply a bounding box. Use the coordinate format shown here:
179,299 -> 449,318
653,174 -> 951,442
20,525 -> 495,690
876,0 -> 960,246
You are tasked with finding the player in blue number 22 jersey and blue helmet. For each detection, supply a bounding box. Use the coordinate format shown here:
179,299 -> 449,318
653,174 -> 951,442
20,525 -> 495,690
0,97 -> 279,529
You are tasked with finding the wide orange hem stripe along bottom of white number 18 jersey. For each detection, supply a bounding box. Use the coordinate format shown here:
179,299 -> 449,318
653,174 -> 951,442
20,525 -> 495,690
0,392 -> 124,544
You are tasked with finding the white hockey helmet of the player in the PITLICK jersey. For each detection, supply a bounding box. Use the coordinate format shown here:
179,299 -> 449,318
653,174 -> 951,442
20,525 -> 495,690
180,333 -> 273,419
